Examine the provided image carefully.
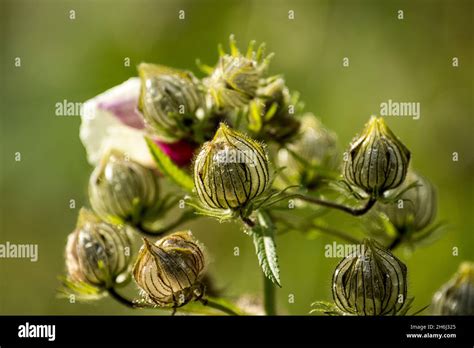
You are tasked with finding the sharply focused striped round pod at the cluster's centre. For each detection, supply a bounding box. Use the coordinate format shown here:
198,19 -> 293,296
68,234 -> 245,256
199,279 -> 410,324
194,123 -> 270,210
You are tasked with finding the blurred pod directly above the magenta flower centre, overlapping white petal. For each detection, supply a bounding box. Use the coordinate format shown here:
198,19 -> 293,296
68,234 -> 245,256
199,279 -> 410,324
138,63 -> 204,141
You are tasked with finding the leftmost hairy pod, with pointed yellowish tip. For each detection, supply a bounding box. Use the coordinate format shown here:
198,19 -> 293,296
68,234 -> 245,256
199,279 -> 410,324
65,208 -> 132,289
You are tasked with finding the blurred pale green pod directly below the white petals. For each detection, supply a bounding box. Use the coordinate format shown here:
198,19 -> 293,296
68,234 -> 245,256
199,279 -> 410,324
89,151 -> 159,224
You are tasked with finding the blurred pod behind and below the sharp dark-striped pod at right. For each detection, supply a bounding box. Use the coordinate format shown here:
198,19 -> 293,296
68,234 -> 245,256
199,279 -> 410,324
376,171 -> 437,232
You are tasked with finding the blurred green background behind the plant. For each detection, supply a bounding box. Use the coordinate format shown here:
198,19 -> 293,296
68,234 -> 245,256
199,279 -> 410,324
0,0 -> 474,314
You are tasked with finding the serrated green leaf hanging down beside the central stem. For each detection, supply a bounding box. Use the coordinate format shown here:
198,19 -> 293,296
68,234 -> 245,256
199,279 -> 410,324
250,212 -> 281,287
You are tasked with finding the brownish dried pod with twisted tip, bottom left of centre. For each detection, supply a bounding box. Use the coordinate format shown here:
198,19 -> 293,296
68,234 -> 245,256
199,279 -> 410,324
133,231 -> 206,307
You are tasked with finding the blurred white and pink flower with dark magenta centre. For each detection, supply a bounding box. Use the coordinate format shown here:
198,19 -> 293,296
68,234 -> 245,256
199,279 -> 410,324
80,78 -> 195,167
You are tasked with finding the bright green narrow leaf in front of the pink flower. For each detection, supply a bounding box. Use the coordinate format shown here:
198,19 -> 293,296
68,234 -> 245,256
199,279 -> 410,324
145,137 -> 194,192
